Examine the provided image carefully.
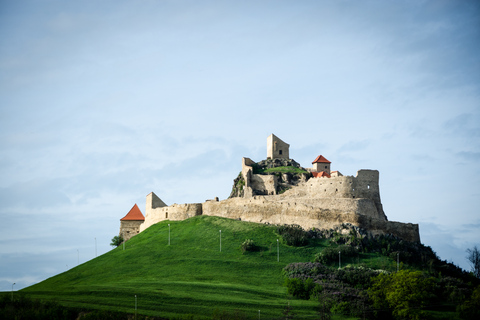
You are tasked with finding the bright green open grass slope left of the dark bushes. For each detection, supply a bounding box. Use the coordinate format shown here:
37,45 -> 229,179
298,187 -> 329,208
22,216 -> 344,317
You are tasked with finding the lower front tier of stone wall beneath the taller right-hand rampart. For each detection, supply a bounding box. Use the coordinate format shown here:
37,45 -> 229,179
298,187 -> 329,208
202,196 -> 420,241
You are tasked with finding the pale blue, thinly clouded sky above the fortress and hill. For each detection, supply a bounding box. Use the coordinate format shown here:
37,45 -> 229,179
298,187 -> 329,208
0,0 -> 480,290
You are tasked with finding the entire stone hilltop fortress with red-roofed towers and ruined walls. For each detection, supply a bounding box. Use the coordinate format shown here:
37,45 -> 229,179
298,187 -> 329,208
120,134 -> 420,242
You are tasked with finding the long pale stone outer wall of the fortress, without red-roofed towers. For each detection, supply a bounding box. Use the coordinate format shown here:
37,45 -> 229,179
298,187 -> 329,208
126,135 -> 420,242
